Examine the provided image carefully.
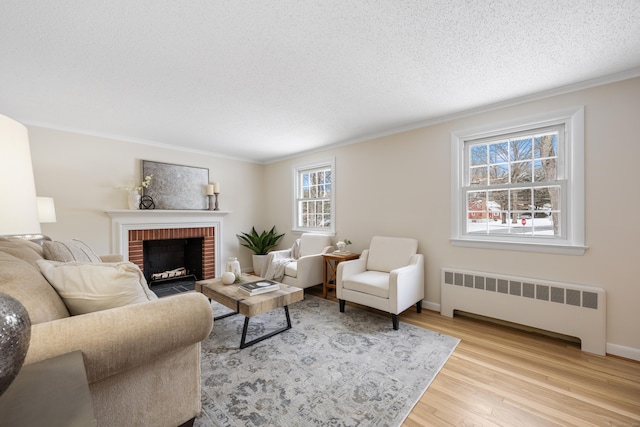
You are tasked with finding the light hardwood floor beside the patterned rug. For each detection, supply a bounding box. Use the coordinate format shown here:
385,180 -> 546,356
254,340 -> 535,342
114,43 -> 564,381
305,287 -> 640,427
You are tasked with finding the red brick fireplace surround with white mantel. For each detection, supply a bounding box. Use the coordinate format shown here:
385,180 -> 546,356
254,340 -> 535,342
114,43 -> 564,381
107,210 -> 228,279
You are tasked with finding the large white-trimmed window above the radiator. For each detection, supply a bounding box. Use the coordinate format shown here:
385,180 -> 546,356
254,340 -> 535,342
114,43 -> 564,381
452,108 -> 585,254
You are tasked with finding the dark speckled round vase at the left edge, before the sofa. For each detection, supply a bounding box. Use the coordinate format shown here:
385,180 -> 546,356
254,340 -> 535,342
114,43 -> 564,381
0,293 -> 31,395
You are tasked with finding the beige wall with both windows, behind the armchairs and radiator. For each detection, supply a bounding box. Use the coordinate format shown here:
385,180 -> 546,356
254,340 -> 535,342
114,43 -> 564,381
265,78 -> 640,359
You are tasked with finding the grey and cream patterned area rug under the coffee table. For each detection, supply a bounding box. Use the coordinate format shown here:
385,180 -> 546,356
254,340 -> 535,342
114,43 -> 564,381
195,295 -> 459,427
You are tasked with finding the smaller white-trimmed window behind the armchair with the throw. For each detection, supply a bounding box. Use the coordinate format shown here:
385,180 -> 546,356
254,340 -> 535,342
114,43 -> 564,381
293,160 -> 335,233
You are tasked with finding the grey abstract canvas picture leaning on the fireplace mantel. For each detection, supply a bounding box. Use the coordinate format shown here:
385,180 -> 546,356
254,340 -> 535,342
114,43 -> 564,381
142,160 -> 209,210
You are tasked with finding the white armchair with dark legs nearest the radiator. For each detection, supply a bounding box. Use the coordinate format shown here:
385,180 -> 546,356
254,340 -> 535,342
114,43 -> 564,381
336,236 -> 424,329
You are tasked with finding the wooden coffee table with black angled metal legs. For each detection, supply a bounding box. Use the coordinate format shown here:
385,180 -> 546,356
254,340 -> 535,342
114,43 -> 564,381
195,275 -> 304,348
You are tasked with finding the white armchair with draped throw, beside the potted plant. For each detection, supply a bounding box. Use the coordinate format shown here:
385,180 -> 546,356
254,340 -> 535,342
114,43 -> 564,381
264,233 -> 333,289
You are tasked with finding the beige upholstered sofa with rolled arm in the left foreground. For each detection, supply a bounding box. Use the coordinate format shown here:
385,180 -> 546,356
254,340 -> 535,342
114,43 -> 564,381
0,238 -> 213,427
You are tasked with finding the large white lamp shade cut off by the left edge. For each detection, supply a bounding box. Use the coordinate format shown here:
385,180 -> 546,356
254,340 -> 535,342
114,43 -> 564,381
0,114 -> 41,236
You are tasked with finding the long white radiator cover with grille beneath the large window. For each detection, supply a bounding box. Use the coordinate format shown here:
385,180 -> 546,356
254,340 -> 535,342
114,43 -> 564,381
440,268 -> 607,355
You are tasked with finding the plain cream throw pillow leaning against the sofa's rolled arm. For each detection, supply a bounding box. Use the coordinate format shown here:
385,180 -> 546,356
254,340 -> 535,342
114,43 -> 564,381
38,260 -> 158,315
